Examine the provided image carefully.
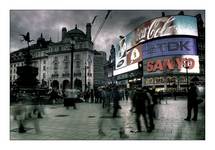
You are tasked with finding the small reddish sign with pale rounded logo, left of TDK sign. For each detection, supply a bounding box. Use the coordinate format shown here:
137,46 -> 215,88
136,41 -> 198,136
127,44 -> 143,65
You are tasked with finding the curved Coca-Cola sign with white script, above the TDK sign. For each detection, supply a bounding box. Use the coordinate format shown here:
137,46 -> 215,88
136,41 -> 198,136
135,16 -> 198,43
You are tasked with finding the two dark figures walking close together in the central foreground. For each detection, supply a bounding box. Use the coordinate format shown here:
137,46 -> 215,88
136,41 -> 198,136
133,87 -> 154,132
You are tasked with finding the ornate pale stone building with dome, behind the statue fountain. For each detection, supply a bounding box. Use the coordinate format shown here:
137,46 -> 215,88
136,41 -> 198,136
10,23 -> 95,91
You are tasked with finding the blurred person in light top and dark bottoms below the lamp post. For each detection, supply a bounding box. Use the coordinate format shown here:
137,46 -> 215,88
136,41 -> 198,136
64,85 -> 79,109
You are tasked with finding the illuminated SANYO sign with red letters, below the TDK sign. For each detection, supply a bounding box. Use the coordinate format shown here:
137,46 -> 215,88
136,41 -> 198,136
143,55 -> 199,76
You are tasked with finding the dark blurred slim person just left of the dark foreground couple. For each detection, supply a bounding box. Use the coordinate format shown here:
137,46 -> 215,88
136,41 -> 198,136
112,86 -> 121,118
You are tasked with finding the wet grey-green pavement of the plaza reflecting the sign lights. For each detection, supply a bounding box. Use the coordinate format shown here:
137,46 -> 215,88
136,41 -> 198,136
10,98 -> 205,140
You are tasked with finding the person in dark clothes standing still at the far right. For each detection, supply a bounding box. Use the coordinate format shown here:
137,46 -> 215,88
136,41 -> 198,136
184,82 -> 198,121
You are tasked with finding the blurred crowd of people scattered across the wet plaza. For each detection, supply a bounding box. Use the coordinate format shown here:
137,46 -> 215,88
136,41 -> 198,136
10,83 -> 202,138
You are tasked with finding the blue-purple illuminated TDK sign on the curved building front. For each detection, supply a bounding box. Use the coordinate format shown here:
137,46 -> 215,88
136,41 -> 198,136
143,37 -> 197,59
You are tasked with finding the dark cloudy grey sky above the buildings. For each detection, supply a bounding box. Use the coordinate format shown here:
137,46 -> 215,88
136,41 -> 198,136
10,10 -> 205,54
